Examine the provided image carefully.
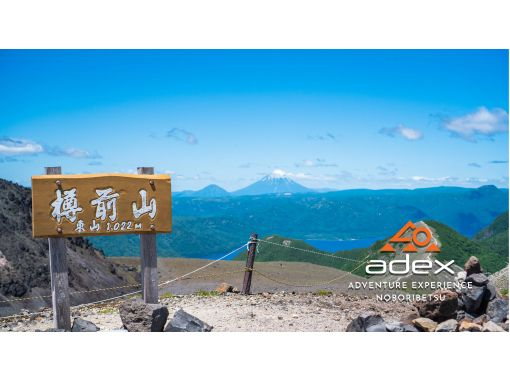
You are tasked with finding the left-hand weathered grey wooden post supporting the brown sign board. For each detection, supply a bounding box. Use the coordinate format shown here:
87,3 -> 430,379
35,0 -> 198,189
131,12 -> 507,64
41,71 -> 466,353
44,166 -> 71,331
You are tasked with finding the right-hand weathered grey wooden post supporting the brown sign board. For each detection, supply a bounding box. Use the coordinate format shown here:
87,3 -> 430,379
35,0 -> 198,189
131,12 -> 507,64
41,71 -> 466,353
137,167 -> 158,303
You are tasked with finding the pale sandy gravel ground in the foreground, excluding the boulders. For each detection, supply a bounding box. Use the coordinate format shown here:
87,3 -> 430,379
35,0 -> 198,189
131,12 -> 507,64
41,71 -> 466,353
0,292 -> 415,332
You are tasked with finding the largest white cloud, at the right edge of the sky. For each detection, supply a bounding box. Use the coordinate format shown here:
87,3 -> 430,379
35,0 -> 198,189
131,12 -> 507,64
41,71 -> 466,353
443,107 -> 508,142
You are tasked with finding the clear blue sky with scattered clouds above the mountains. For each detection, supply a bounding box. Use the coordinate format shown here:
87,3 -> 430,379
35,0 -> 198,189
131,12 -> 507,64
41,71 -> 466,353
0,50 -> 508,190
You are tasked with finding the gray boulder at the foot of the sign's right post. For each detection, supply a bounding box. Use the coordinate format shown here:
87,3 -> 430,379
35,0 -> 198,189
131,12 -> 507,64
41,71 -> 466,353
119,298 -> 169,332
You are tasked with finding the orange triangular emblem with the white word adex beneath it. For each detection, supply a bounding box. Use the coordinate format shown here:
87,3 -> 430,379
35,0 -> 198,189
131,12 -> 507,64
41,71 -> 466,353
365,221 -> 455,275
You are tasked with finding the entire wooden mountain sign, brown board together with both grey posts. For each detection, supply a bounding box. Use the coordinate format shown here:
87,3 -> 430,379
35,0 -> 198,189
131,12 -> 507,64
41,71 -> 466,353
32,167 -> 172,330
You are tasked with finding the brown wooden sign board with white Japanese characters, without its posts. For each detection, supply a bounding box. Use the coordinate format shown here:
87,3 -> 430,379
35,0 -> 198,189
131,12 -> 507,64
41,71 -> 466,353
32,174 -> 172,237
